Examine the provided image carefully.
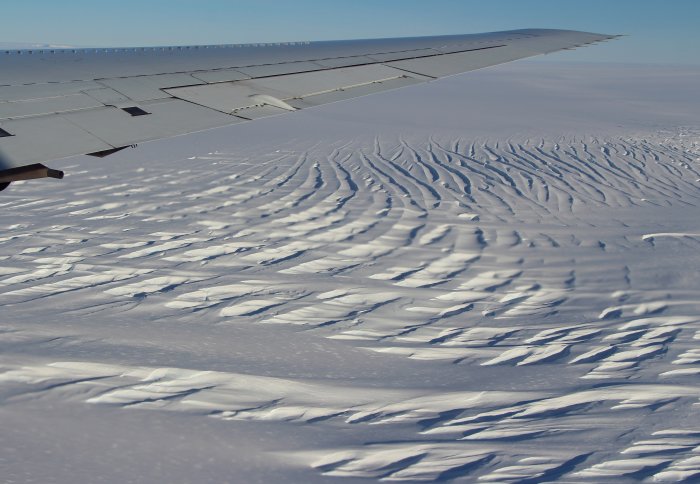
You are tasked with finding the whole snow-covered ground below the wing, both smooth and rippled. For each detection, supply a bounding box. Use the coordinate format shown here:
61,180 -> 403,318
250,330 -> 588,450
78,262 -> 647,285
0,62 -> 700,482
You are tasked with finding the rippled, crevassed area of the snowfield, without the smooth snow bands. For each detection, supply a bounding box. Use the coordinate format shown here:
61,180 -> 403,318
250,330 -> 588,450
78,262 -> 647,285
0,132 -> 700,482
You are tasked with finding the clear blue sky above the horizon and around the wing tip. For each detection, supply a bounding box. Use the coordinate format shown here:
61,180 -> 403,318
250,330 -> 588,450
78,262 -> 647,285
0,0 -> 700,65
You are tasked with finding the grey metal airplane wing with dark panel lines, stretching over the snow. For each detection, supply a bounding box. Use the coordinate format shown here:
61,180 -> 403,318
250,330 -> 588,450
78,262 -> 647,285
0,29 -> 616,190
